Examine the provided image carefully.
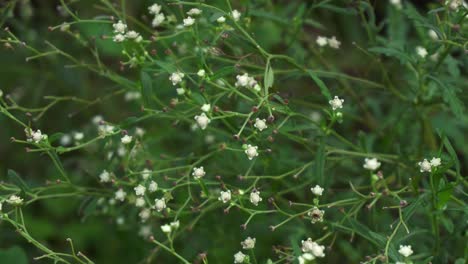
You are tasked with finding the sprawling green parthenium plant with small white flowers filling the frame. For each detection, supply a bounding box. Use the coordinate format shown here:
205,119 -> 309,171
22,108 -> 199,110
0,0 -> 468,263
